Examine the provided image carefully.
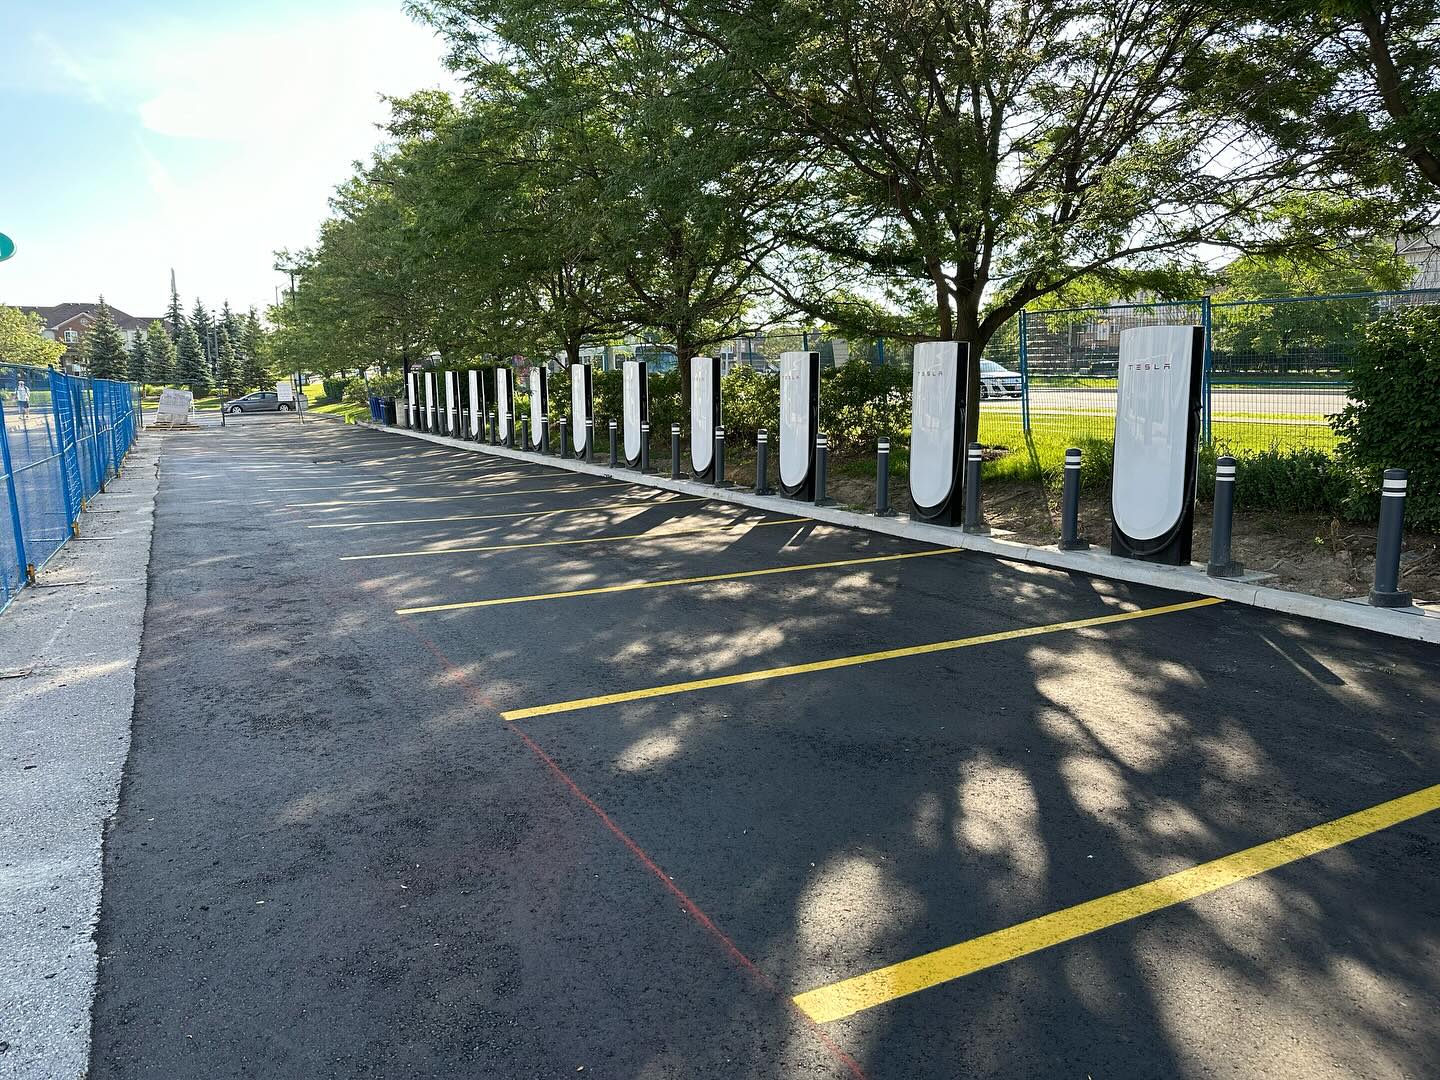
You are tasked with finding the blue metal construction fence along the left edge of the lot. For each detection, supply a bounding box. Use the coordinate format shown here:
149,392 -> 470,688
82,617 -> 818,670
0,363 -> 141,611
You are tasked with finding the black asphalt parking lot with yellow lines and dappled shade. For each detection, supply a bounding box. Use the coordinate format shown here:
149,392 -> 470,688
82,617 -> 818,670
92,418 -> 1440,1079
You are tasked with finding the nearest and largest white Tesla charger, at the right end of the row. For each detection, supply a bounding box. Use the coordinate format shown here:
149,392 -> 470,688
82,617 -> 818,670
1110,325 -> 1205,566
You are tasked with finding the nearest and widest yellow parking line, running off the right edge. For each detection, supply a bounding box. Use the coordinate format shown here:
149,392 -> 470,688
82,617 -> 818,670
795,783 -> 1440,1024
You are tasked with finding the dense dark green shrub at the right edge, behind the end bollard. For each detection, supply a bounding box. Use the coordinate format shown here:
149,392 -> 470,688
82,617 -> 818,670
1332,305 -> 1440,528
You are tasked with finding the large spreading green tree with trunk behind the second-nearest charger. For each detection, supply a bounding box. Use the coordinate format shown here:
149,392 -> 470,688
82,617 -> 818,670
590,0 -> 1353,439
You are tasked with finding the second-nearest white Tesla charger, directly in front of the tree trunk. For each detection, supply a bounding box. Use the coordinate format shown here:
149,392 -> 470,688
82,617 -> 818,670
910,341 -> 971,526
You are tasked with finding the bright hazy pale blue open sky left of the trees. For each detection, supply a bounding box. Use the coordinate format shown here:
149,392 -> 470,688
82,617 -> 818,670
0,0 -> 455,315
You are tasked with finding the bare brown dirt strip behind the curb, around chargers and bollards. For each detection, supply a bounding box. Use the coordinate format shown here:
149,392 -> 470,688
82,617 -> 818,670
726,443 -> 1440,603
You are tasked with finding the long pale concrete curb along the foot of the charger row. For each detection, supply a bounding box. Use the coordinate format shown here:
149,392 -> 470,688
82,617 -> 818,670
354,420 -> 1440,644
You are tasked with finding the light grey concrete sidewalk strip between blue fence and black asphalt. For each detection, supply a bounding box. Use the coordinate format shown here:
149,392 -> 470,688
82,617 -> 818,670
0,435 -> 161,1080
